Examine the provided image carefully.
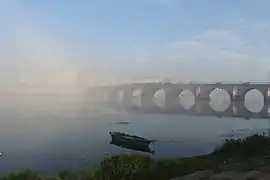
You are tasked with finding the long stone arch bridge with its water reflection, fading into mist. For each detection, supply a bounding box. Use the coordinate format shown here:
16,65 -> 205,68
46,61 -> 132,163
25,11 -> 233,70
88,83 -> 270,118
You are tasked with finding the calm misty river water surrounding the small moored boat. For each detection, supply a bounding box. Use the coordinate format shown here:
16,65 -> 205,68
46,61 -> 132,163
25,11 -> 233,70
0,95 -> 270,174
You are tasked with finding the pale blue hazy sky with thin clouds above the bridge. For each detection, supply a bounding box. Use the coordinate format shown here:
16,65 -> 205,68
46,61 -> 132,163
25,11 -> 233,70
0,0 -> 270,92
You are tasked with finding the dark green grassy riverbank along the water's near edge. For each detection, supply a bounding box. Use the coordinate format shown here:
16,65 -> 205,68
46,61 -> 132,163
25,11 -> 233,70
3,135 -> 270,180
